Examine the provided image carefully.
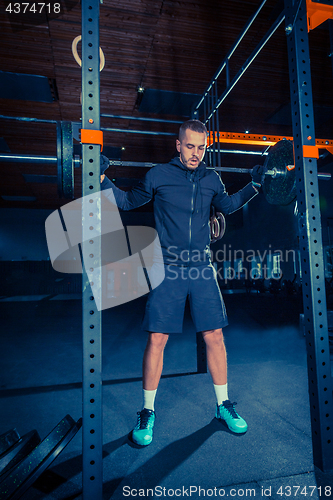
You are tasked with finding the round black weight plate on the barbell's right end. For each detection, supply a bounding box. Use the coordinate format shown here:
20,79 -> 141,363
262,139 -> 296,205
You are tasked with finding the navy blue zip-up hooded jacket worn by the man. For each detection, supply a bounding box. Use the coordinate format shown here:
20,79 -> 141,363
101,158 -> 257,266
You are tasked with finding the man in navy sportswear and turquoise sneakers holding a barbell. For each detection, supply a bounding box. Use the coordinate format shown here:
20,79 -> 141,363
101,120 -> 264,446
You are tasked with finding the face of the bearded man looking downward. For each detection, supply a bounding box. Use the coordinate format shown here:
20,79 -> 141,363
176,129 -> 207,169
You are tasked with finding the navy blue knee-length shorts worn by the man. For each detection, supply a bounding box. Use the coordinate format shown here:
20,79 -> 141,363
142,264 -> 228,333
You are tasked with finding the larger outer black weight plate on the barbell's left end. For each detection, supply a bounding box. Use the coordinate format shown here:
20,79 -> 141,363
61,122 -> 74,199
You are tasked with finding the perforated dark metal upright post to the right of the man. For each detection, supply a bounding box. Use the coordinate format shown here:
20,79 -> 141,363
285,0 -> 333,471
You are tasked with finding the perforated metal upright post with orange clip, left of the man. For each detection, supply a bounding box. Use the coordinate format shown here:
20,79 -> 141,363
81,0 -> 103,500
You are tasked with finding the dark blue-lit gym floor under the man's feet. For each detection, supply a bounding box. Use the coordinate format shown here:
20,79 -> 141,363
0,293 -> 333,500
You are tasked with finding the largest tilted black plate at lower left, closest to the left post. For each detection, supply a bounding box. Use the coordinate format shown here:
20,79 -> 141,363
0,415 -> 81,500
